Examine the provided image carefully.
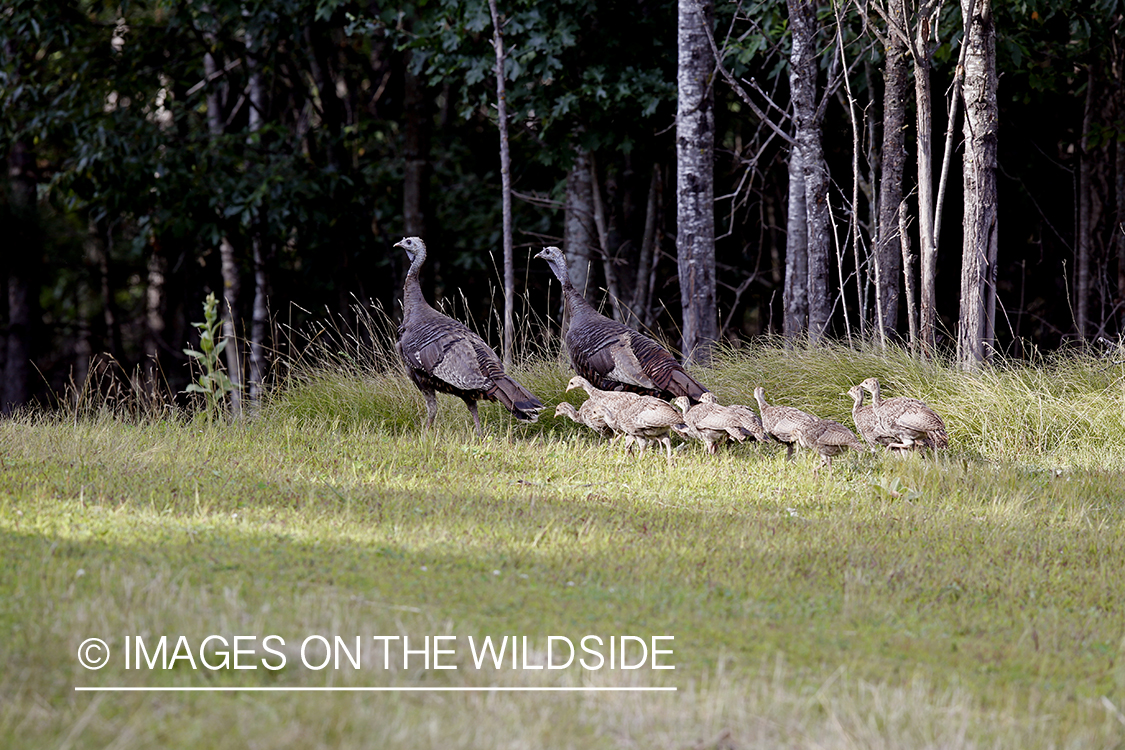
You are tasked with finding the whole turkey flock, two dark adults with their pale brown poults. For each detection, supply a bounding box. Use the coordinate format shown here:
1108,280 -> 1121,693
395,237 -> 948,466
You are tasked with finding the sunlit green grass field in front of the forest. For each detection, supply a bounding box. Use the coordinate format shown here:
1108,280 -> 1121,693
0,342 -> 1125,749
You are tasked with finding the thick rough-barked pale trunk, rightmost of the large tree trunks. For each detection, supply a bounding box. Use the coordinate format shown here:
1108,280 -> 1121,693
957,0 -> 999,370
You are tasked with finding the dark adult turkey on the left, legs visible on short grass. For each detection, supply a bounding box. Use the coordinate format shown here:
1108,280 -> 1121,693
395,237 -> 543,437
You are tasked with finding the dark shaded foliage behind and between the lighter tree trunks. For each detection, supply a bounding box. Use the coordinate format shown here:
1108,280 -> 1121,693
0,0 -> 1125,407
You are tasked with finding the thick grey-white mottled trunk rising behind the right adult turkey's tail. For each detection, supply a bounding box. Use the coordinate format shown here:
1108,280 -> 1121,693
676,0 -> 719,363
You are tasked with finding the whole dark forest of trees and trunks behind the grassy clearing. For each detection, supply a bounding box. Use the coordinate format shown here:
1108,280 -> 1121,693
0,0 -> 1125,410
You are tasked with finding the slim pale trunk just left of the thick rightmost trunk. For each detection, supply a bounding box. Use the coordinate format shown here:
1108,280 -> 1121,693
914,3 -> 937,353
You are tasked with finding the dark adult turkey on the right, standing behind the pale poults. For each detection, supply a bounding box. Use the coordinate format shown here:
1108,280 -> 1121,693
536,247 -> 707,401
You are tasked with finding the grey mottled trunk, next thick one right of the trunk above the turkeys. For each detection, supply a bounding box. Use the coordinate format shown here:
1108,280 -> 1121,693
788,0 -> 831,342
